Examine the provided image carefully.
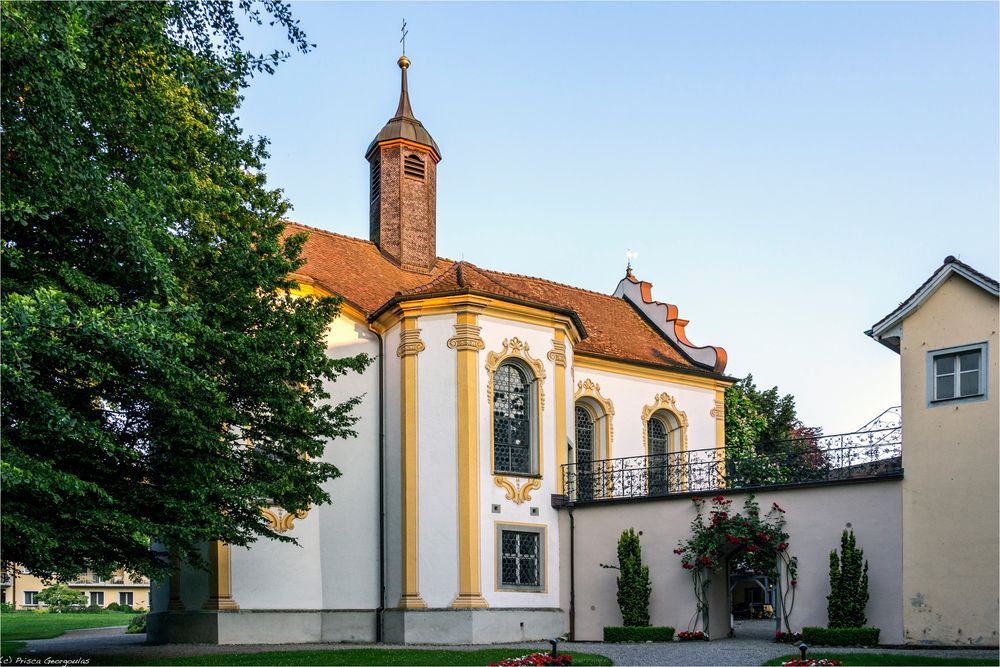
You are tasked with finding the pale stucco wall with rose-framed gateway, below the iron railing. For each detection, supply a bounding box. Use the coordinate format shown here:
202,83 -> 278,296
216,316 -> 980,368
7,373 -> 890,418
562,479 -> 903,644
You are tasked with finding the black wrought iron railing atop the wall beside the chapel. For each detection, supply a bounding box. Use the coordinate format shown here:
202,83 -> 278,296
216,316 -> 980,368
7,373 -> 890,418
562,426 -> 903,503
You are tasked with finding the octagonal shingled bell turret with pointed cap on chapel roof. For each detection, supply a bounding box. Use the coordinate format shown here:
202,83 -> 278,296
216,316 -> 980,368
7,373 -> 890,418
365,55 -> 441,273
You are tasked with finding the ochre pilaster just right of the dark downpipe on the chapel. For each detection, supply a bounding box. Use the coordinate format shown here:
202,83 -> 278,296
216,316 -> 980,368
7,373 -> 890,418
396,313 -> 427,609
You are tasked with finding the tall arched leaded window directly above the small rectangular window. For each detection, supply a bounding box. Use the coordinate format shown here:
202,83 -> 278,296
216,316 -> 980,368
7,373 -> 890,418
493,364 -> 533,474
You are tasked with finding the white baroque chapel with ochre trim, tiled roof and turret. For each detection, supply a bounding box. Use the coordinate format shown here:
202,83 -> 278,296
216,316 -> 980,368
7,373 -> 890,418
150,56 -> 734,643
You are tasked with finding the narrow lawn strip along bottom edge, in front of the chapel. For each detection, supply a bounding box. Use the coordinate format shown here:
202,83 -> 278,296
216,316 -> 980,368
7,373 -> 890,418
122,648 -> 613,666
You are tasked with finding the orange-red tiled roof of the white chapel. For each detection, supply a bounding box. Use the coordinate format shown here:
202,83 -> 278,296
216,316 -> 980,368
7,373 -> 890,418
288,223 -> 725,377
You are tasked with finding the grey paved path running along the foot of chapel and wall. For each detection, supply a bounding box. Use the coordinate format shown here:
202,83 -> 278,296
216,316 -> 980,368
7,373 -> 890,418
20,628 -> 998,665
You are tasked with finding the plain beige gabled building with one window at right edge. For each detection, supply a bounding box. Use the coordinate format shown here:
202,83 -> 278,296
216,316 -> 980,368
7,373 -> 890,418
867,256 -> 1000,645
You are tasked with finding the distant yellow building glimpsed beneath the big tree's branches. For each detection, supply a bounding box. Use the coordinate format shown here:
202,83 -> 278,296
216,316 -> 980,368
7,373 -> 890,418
0,567 -> 149,610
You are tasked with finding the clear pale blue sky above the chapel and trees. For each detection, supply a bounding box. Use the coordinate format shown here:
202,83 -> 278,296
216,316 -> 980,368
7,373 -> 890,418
241,2 -> 1000,436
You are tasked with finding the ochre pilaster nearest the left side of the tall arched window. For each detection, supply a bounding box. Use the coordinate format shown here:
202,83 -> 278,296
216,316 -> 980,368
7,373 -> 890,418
448,310 -> 489,609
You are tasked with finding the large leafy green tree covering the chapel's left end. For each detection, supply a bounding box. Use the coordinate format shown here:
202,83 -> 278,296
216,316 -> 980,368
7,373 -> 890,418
0,0 -> 367,578
